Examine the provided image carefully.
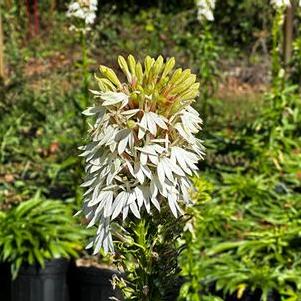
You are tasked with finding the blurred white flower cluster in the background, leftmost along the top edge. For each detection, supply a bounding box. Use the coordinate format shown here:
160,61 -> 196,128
67,0 -> 97,26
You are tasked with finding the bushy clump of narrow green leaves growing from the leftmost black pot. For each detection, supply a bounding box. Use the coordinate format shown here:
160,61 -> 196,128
0,194 -> 86,277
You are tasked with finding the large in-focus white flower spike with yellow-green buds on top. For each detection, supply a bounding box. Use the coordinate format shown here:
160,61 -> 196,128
81,55 -> 204,253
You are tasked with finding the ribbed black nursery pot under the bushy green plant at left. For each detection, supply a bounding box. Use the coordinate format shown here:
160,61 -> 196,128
11,259 -> 68,301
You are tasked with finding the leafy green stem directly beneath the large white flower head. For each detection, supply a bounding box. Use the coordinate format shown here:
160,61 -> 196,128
114,206 -> 185,301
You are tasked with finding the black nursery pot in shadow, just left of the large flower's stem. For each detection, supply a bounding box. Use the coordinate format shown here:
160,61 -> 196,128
67,263 -> 122,301
